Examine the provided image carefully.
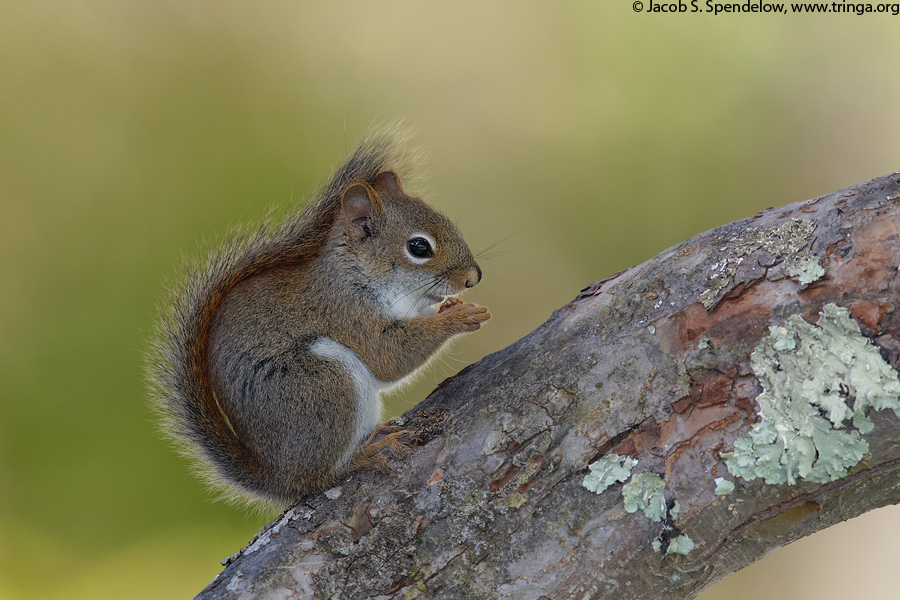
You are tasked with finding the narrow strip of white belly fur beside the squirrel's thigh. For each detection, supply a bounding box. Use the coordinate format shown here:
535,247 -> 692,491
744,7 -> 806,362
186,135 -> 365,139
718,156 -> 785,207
309,337 -> 392,470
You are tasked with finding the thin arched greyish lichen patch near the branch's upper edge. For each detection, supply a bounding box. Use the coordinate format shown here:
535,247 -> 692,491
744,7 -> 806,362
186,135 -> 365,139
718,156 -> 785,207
699,219 -> 825,310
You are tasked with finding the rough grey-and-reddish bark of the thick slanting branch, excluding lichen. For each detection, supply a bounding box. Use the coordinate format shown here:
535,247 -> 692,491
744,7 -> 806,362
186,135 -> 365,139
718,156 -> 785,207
198,174 -> 900,599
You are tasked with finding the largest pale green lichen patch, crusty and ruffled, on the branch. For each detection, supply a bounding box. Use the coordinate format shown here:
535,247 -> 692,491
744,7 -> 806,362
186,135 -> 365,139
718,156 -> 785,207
723,304 -> 900,484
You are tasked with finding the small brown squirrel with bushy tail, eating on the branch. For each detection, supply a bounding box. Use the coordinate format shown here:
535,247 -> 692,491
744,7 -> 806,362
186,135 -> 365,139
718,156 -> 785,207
150,131 -> 491,506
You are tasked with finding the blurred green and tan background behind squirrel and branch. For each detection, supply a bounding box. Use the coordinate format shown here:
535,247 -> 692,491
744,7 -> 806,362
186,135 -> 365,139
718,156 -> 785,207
0,0 -> 900,600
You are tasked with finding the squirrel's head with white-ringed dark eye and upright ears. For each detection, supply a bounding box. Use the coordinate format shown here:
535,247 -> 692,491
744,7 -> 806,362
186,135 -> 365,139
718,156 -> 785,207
338,171 -> 481,319
